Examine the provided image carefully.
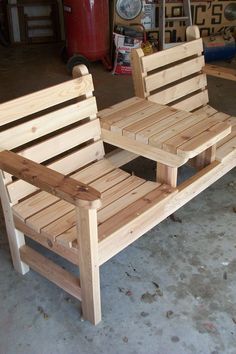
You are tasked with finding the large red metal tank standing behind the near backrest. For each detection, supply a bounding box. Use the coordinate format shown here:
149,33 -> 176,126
64,0 -> 109,71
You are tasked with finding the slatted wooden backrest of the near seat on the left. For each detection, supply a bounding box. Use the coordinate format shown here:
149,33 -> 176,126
0,68 -> 104,204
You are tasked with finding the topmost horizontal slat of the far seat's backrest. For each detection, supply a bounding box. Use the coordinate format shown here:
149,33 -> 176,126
142,39 -> 203,72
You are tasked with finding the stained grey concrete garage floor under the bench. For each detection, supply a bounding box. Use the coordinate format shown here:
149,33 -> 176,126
0,45 -> 236,354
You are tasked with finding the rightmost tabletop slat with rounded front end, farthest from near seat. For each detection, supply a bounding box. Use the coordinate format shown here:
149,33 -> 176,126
177,122 -> 231,158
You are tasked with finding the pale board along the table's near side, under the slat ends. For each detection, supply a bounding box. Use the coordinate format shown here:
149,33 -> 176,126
102,129 -> 188,167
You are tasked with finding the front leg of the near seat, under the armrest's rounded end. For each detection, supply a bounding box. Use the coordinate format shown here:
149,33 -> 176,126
76,208 -> 101,325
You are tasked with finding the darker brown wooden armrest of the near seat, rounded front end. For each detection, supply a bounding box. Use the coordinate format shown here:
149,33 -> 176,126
0,150 -> 101,208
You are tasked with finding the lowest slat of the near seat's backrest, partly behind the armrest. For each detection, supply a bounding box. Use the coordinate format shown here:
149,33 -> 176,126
7,140 -> 104,204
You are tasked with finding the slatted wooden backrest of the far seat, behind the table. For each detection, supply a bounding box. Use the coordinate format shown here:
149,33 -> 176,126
131,29 -> 208,111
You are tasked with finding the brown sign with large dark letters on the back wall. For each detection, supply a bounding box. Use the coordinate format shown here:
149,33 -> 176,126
115,0 -> 236,42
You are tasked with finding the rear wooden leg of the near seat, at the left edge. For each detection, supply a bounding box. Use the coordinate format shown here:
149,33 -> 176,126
0,172 -> 29,274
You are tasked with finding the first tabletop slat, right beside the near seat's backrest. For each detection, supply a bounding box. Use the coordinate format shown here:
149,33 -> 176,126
98,100 -> 153,130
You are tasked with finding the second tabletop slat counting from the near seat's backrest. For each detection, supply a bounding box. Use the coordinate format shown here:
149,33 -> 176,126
110,103 -> 165,135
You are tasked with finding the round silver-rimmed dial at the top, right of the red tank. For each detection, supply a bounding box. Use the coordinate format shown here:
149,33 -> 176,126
116,0 -> 142,20
